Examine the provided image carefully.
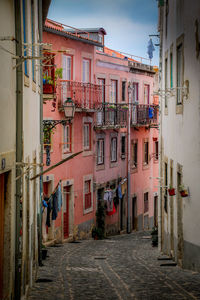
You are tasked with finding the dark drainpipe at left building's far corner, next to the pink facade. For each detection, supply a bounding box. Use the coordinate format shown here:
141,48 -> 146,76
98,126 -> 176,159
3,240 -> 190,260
37,0 -> 43,265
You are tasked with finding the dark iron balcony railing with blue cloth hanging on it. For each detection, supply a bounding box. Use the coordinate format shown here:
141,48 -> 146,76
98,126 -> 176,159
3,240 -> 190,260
131,104 -> 158,126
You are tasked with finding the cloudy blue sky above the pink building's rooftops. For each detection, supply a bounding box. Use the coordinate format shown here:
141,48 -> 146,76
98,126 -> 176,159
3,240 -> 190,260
48,0 -> 158,65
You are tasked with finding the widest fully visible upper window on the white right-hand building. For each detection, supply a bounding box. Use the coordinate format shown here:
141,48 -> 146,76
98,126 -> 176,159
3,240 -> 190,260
176,44 -> 183,105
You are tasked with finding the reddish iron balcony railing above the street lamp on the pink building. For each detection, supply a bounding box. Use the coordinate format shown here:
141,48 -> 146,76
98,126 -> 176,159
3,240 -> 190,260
57,80 -> 102,110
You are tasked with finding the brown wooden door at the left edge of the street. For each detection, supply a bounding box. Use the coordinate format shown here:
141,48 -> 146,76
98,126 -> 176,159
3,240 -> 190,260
0,174 -> 5,299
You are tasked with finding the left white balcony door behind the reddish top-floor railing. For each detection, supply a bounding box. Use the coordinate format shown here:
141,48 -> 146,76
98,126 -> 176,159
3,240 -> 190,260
62,55 -> 73,102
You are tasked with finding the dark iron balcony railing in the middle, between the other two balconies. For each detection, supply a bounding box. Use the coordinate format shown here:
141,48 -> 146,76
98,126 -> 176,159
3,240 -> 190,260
95,103 -> 128,128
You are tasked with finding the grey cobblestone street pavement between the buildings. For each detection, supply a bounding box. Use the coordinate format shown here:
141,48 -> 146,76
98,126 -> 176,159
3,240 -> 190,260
29,232 -> 200,300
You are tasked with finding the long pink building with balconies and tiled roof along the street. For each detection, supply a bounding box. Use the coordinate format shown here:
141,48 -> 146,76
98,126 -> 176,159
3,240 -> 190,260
43,20 -> 158,242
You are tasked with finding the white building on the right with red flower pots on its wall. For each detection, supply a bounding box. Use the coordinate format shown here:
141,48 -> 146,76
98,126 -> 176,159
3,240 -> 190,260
158,0 -> 200,271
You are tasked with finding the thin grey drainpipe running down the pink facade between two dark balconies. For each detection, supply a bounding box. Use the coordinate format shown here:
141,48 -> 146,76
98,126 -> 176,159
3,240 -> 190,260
127,87 -> 131,233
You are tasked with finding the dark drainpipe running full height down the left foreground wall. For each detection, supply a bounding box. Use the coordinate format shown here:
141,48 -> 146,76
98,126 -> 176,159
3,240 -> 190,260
14,0 -> 23,300
